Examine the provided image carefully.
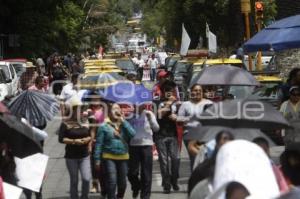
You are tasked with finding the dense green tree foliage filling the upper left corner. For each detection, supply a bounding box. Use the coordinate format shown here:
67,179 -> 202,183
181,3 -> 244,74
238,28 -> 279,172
0,0 -> 137,57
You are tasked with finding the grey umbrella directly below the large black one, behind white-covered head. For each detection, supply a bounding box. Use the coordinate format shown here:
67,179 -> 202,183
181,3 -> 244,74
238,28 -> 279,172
183,123 -> 275,146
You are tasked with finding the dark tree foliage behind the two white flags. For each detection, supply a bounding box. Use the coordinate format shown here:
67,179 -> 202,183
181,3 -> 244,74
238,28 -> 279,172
140,0 -> 276,48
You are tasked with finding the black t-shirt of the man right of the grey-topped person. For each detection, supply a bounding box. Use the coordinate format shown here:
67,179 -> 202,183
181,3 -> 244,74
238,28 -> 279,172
157,102 -> 177,137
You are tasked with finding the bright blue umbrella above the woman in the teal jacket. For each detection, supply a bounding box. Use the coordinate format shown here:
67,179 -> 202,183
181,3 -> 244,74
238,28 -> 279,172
102,82 -> 152,104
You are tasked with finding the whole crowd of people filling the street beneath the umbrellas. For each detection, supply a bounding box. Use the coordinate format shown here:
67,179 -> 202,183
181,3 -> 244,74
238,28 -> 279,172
0,51 -> 300,199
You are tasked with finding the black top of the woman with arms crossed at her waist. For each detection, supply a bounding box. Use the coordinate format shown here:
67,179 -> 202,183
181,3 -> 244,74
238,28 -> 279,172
59,123 -> 90,159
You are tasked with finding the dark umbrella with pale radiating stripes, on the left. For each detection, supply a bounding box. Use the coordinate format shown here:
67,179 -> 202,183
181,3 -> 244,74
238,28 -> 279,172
9,90 -> 59,127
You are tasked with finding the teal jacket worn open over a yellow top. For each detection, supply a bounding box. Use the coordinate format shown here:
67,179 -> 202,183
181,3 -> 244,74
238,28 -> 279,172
94,121 -> 135,162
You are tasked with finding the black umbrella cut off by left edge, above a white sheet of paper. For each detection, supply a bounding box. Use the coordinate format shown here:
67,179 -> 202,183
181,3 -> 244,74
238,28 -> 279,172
0,113 -> 42,158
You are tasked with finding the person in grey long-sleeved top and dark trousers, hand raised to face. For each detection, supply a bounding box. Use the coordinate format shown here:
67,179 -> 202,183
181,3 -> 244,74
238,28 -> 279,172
128,105 -> 159,199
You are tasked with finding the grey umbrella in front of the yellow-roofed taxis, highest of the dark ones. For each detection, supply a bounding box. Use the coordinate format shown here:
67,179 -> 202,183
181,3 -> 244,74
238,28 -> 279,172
190,65 -> 259,86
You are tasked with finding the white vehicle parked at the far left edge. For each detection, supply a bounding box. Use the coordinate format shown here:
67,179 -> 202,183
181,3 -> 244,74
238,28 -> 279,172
0,61 -> 19,96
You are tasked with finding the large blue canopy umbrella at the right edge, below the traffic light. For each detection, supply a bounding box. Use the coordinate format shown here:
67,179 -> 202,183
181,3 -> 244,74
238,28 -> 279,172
244,15 -> 300,52
